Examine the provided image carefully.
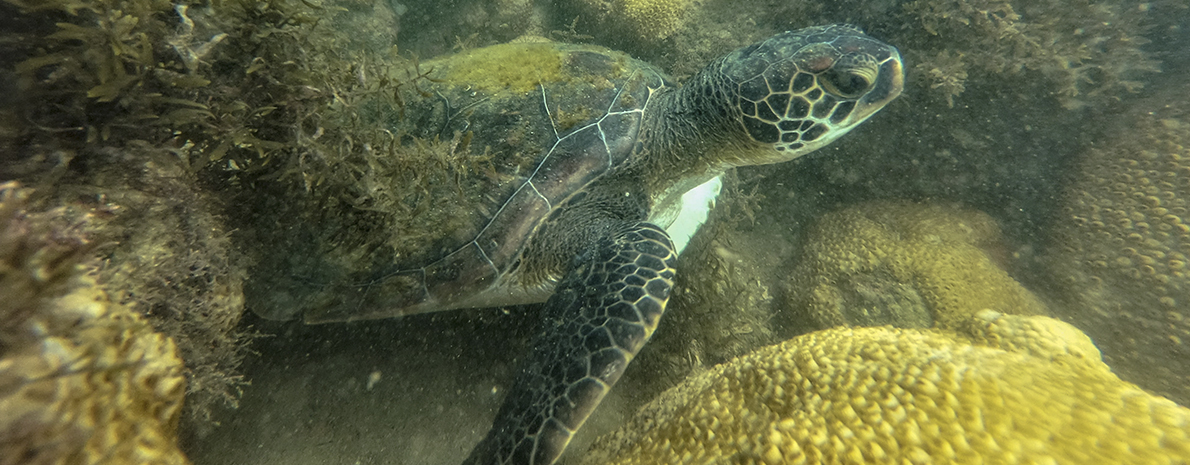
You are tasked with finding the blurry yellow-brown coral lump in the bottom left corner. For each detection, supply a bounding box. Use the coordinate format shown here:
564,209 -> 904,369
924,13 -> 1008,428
0,184 -> 188,465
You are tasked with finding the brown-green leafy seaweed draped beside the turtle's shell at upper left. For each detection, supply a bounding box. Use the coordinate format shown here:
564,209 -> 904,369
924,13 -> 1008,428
0,0 -> 416,432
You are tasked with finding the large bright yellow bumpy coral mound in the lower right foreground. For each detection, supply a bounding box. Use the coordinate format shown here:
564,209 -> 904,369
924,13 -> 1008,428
584,310 -> 1190,464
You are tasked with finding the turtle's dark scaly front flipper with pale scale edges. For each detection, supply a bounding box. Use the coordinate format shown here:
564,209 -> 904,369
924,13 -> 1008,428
464,222 -> 677,465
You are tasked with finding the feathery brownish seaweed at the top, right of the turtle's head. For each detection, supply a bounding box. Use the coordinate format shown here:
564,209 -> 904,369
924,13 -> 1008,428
904,0 -> 1158,108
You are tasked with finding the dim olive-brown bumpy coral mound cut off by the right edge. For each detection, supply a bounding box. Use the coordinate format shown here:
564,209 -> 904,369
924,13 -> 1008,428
1050,86 -> 1190,404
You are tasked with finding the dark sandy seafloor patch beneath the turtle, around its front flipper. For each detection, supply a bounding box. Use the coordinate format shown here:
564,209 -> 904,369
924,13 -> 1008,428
187,307 -> 647,465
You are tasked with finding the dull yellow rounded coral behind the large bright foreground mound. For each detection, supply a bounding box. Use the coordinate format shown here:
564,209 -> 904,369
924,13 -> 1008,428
788,201 -> 1046,328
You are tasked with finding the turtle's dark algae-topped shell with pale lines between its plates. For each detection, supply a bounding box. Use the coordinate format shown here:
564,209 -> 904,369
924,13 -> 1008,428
253,42 -> 669,322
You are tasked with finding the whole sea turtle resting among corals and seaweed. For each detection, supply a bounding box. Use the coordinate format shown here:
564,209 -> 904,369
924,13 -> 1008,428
250,25 -> 903,465
